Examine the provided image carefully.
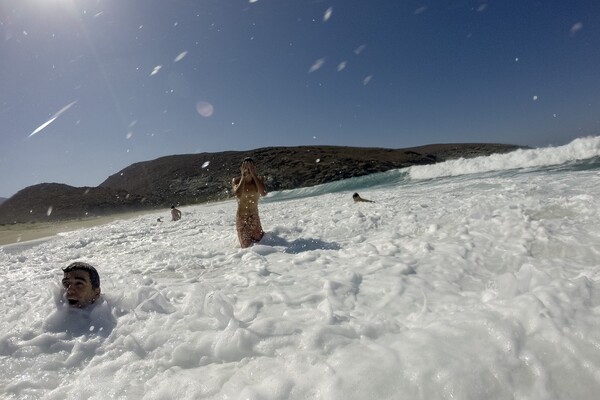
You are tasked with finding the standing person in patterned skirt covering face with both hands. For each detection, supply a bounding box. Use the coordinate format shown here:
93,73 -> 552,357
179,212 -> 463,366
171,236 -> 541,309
231,157 -> 267,248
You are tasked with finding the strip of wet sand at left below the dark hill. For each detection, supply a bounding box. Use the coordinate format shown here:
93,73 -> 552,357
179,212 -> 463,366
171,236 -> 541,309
0,210 -> 161,246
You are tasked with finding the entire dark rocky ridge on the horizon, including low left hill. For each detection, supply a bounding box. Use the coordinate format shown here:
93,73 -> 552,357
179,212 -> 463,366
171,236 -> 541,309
0,143 -> 519,224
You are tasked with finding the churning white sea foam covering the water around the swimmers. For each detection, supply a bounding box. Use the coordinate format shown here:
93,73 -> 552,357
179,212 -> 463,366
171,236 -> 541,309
0,139 -> 600,400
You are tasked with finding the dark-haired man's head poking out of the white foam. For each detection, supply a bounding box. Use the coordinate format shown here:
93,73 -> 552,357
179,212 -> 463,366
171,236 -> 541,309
62,262 -> 100,308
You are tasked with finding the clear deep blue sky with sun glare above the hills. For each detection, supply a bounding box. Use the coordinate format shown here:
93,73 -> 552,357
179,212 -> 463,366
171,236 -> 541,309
0,0 -> 600,197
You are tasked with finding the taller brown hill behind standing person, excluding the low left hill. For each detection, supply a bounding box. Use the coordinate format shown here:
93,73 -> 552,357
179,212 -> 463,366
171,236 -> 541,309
100,144 -> 517,205
